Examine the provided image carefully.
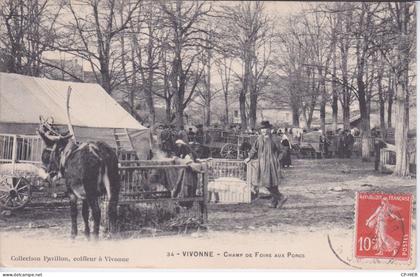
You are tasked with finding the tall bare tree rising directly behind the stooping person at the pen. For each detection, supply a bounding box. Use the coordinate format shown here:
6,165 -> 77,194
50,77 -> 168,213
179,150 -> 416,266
160,0 -> 212,128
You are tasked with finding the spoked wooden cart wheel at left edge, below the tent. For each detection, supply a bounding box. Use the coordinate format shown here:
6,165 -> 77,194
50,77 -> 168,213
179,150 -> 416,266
0,176 -> 31,210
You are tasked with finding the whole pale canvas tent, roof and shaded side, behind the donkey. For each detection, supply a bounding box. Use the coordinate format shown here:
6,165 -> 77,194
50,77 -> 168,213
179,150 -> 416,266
0,73 -> 150,158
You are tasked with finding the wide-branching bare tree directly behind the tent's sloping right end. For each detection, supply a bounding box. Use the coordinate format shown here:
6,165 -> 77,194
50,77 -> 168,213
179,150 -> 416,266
54,0 -> 141,94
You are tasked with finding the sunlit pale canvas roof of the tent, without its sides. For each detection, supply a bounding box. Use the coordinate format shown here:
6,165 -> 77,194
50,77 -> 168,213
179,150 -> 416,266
0,72 -> 146,130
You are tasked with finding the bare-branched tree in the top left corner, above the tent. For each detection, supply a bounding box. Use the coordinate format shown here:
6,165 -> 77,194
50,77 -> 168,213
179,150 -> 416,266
0,0 -> 62,76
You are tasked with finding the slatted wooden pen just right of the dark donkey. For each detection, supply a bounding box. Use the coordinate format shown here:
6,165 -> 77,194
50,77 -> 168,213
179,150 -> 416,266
113,160 -> 208,222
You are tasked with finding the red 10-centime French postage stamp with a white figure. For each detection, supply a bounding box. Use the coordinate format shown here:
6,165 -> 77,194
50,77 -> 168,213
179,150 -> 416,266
355,192 -> 412,260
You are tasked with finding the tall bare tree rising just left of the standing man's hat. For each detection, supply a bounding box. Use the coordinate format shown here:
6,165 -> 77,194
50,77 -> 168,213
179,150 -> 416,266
219,1 -> 274,129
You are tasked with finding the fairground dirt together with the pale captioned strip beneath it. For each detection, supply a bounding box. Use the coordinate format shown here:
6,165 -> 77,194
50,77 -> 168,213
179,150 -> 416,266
0,159 -> 416,269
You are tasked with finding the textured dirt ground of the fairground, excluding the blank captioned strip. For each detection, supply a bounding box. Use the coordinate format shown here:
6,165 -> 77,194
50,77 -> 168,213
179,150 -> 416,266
0,159 -> 416,239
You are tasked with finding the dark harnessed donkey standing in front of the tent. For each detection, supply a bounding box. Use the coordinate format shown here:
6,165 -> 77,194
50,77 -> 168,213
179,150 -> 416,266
38,126 -> 120,239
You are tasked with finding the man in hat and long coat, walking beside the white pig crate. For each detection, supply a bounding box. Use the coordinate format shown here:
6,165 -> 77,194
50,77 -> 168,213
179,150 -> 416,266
245,121 -> 287,208
